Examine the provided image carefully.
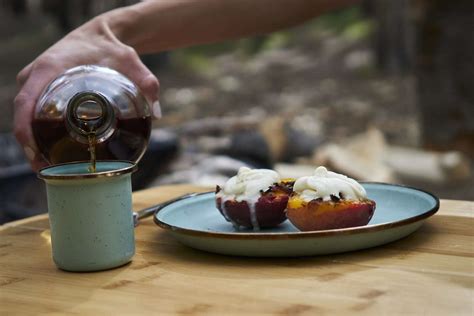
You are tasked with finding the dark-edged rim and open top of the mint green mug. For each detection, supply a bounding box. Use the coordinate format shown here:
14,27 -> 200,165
38,160 -> 138,180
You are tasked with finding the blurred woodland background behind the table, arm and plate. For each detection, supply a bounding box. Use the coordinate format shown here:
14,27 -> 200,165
0,0 -> 474,223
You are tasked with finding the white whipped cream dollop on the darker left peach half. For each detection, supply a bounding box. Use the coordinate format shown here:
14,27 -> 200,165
217,167 -> 280,202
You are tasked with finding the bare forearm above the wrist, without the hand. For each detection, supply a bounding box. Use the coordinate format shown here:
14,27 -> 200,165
104,0 -> 356,53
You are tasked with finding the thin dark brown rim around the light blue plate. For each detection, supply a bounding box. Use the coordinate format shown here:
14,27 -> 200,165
153,181 -> 439,240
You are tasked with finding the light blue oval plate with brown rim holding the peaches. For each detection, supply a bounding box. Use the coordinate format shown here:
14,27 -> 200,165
154,183 -> 439,257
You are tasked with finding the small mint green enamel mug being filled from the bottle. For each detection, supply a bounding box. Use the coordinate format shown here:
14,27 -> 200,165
39,161 -> 136,271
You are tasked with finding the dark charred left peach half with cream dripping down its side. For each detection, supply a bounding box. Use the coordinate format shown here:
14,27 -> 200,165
216,180 -> 294,230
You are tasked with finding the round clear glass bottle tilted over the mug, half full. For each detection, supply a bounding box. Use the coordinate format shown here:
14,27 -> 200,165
32,65 -> 151,164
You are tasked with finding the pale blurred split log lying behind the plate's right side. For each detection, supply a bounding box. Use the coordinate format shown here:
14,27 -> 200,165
312,129 -> 471,184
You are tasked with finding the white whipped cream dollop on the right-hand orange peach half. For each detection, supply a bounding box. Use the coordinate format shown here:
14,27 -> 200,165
293,167 -> 367,202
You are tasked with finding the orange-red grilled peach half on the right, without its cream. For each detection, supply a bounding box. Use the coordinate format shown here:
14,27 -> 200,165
286,195 -> 375,231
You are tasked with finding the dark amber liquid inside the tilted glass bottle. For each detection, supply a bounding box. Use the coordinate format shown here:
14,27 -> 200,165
32,116 -> 151,165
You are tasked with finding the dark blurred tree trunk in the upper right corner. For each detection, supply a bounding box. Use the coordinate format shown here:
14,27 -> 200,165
415,0 -> 474,157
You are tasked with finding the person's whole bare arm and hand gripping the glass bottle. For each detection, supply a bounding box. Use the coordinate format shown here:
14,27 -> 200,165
14,0 -> 355,170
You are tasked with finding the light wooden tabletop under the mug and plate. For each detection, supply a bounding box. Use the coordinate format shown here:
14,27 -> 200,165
0,185 -> 474,315
